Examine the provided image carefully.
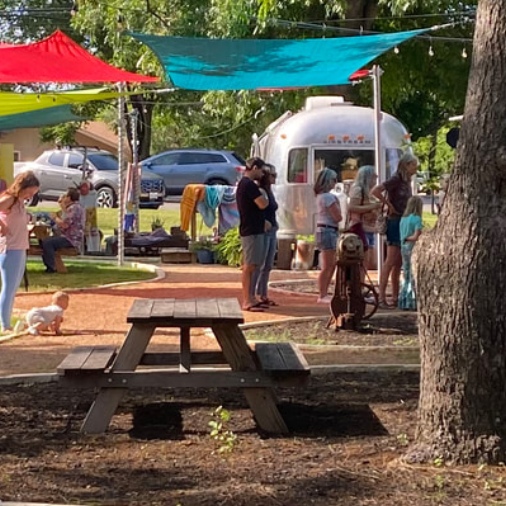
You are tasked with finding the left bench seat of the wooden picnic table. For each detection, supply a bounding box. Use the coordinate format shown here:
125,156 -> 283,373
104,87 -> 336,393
56,346 -> 117,375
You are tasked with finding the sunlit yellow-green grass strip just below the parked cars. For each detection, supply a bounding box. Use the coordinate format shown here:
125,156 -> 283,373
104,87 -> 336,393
28,207 -> 212,237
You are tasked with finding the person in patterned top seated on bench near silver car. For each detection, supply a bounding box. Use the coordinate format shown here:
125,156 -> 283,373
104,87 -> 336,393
41,188 -> 84,274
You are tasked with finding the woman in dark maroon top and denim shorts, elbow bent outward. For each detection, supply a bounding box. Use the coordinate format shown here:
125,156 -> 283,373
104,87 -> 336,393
371,153 -> 418,308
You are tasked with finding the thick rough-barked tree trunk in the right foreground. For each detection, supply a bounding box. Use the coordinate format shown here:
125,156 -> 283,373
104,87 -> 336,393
408,0 -> 506,463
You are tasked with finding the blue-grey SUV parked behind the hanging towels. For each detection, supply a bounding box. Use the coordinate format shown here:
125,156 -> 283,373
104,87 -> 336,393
141,149 -> 246,195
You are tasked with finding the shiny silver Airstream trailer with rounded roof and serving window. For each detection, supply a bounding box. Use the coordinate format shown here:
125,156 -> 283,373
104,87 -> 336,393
252,96 -> 410,237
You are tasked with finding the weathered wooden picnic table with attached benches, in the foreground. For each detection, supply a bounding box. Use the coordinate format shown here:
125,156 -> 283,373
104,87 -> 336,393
57,298 -> 310,433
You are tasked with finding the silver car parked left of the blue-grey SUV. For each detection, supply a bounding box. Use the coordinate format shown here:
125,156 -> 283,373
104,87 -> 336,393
16,147 -> 165,209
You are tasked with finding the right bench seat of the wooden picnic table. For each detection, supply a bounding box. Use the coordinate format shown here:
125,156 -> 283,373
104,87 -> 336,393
255,343 -> 311,386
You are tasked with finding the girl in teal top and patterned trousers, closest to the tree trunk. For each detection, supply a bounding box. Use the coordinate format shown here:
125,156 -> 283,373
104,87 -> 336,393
399,197 -> 423,310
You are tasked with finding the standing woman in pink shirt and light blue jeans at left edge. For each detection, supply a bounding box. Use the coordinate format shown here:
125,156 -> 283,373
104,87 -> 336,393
0,171 -> 39,332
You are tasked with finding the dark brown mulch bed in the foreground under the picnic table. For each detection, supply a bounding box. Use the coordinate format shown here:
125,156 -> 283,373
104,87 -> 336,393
0,373 -> 506,506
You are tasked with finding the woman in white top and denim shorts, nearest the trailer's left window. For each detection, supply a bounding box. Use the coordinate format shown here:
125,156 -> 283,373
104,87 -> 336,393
313,168 -> 342,304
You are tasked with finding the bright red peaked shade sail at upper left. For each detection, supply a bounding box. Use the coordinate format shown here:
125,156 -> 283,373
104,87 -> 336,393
0,30 -> 158,83
